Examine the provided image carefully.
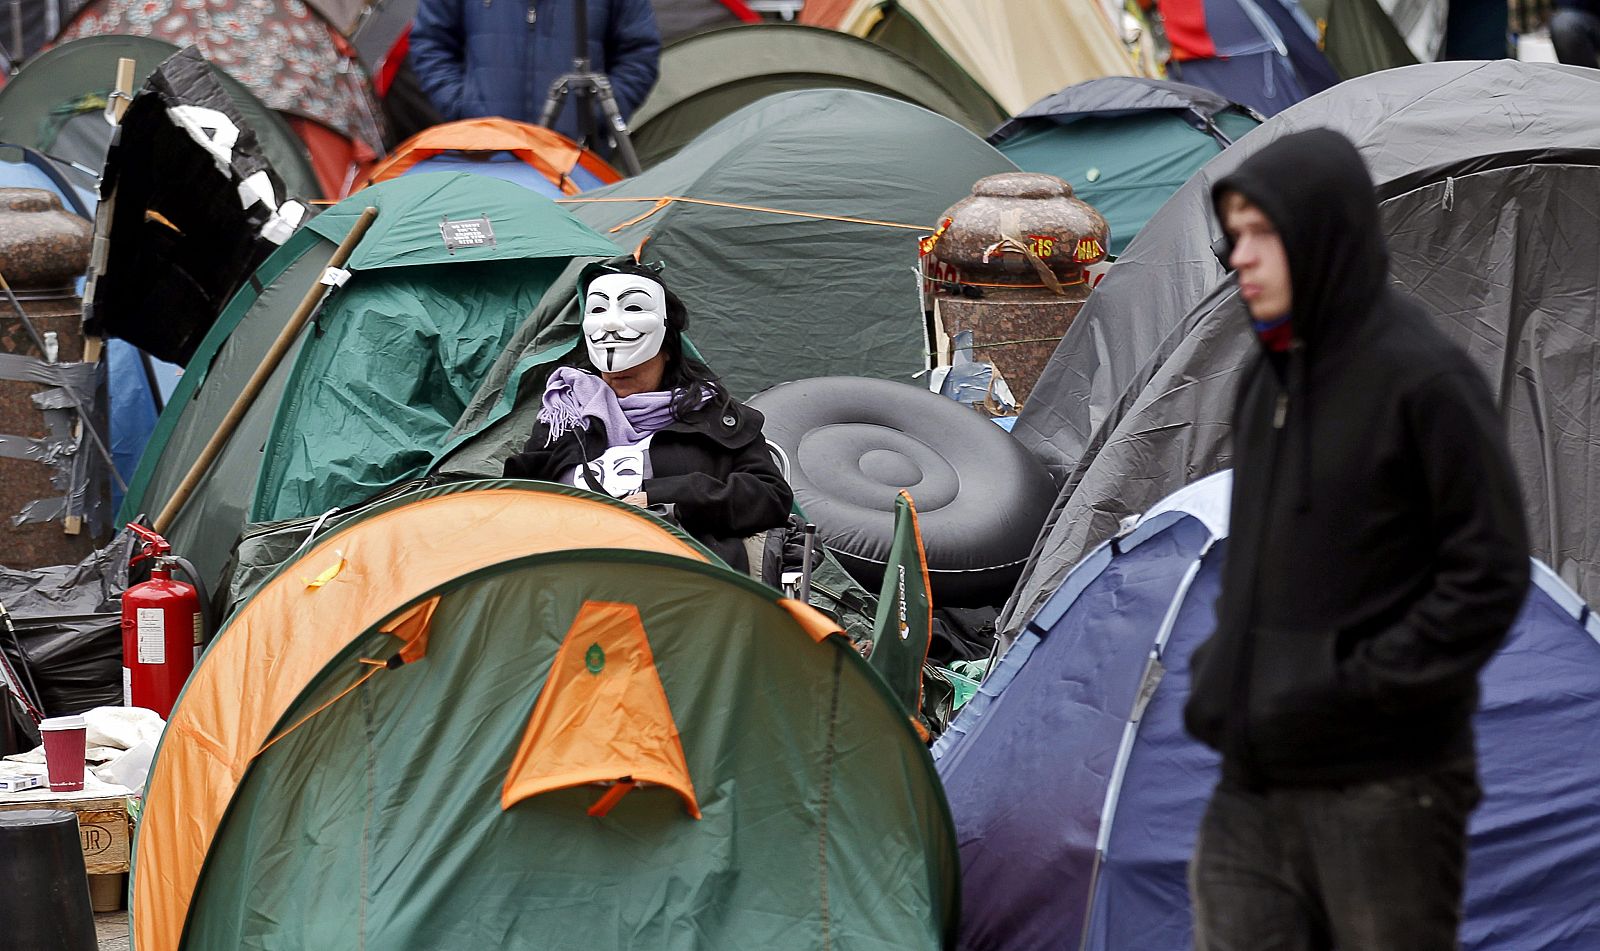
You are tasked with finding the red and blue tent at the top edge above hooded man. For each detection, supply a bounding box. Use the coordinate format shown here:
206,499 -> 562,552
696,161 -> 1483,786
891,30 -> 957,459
1158,0 -> 1339,117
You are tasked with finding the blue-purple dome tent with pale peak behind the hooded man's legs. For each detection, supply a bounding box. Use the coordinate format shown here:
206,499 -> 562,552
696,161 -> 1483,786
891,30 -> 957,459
934,472 -> 1600,951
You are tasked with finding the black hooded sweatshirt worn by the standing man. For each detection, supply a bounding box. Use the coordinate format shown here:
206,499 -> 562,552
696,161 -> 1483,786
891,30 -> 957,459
1184,130 -> 1528,788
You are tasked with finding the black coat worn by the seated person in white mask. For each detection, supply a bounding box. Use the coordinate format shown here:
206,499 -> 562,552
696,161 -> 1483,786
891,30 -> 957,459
506,393 -> 794,572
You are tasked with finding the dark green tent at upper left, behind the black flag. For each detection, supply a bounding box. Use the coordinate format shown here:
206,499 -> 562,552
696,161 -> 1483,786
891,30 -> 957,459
0,35 -> 322,199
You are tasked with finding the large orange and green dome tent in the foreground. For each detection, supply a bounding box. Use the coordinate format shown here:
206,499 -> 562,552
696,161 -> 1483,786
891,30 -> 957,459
131,480 -> 958,951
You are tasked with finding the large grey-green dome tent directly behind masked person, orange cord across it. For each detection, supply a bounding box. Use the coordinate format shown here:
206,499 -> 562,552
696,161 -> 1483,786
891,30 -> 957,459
563,88 -> 1016,397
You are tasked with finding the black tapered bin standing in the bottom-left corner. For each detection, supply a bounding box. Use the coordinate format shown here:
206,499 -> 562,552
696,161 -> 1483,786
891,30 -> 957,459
0,809 -> 99,951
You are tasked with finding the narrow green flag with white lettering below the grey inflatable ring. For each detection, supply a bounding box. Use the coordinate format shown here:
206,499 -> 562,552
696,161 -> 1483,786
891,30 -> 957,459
867,490 -> 933,720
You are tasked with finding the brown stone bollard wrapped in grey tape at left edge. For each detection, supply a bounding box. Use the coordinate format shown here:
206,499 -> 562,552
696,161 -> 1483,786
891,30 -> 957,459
0,189 -> 112,568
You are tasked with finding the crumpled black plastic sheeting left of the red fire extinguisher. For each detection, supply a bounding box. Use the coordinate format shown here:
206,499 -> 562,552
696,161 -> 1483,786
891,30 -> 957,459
0,530 -> 134,717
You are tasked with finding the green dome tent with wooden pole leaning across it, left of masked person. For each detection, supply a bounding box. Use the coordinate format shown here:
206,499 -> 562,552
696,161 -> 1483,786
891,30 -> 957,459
118,175 -> 618,586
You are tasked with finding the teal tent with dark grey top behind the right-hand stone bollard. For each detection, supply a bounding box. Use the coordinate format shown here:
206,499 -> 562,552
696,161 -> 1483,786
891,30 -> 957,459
989,77 -> 1261,256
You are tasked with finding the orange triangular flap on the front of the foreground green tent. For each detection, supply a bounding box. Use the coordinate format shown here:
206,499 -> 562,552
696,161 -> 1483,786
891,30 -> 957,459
501,600 -> 701,818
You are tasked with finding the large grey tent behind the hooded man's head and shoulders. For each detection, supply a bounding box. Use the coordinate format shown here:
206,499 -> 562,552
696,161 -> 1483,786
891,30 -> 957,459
1000,61 -> 1600,631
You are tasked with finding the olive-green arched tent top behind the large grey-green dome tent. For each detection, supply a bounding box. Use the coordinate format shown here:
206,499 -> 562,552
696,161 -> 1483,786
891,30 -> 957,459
632,22 -> 1005,168
